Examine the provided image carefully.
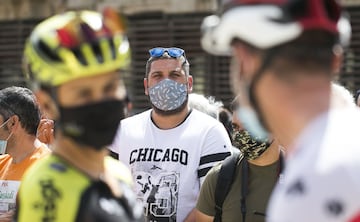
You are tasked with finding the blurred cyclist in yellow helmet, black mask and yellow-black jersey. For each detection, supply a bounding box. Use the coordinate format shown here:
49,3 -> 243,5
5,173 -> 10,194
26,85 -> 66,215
14,8 -> 143,222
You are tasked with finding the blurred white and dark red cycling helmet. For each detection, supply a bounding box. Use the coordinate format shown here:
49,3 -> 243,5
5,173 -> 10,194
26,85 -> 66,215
201,0 -> 344,55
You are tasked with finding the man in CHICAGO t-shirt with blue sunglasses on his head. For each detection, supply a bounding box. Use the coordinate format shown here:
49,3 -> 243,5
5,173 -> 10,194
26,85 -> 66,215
111,47 -> 231,221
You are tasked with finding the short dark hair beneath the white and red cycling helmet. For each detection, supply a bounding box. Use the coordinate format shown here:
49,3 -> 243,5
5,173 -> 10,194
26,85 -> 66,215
233,30 -> 338,79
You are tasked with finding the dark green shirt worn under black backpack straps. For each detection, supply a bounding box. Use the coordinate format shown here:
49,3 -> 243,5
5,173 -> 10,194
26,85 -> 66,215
196,160 -> 280,222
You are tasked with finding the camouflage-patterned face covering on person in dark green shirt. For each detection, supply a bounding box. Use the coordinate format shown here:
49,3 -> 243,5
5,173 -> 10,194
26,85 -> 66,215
232,130 -> 270,160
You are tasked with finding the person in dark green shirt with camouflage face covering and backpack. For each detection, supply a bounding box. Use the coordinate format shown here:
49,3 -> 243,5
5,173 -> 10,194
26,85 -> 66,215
196,98 -> 284,222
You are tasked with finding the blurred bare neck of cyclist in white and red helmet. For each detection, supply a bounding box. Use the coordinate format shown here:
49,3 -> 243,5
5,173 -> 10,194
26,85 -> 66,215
264,76 -> 331,155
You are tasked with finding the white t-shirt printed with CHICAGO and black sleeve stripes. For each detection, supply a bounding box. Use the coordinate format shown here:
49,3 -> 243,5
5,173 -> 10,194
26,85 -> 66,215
111,110 -> 231,221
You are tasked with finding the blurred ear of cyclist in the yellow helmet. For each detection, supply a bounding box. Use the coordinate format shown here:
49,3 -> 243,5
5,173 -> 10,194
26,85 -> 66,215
34,90 -> 59,120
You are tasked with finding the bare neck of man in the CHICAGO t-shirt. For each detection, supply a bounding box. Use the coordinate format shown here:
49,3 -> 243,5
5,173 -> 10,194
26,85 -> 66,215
151,106 -> 189,130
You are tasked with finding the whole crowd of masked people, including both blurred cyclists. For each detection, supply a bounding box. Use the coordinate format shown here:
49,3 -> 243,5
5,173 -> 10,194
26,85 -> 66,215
0,0 -> 360,222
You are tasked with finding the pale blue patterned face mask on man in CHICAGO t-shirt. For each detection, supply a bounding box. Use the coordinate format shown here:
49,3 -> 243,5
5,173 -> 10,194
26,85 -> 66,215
149,79 -> 187,111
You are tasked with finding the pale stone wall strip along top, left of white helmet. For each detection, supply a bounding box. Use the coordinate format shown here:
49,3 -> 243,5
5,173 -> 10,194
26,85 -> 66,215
0,0 -> 217,20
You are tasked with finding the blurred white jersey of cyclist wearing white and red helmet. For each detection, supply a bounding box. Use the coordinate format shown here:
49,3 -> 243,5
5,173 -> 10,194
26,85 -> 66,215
267,108 -> 360,222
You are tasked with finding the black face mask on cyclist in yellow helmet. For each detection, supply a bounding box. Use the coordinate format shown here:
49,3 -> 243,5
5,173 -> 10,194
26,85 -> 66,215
59,100 -> 125,150
